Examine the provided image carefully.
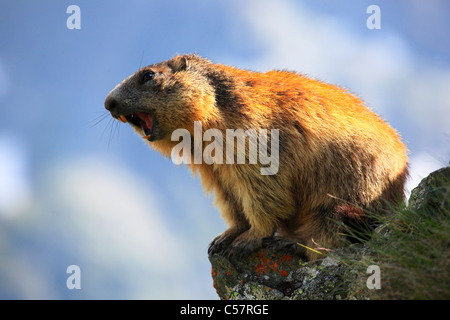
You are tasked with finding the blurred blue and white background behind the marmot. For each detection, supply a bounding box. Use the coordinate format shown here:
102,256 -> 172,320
0,0 -> 450,299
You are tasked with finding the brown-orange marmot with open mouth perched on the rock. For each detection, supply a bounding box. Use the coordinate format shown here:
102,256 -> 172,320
105,55 -> 408,260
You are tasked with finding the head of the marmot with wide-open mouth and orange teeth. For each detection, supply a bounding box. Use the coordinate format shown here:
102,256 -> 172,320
105,55 -> 217,142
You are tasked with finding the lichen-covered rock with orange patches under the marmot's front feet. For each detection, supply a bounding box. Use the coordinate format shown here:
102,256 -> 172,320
209,241 -> 358,300
